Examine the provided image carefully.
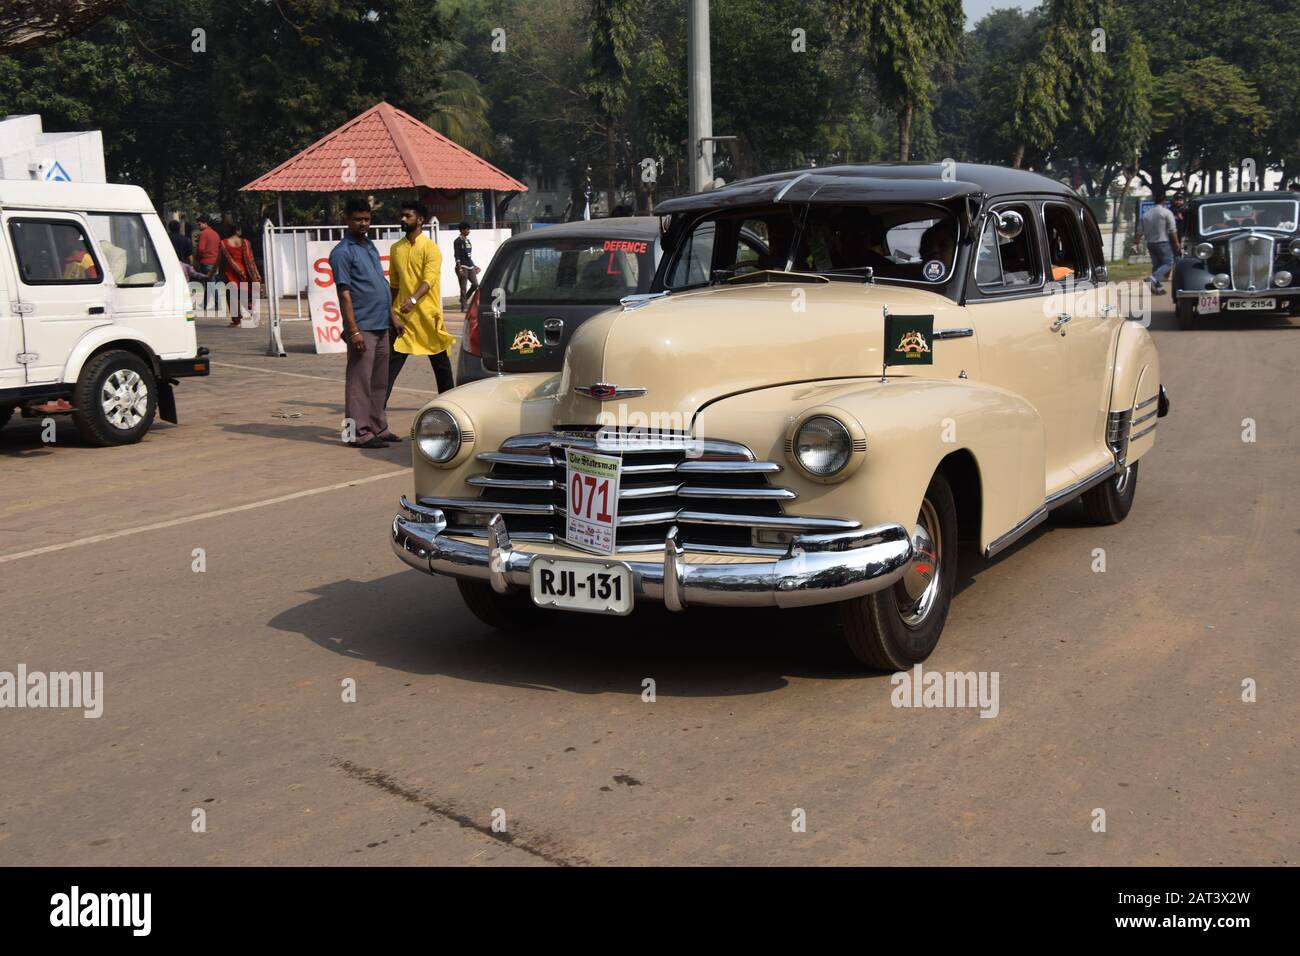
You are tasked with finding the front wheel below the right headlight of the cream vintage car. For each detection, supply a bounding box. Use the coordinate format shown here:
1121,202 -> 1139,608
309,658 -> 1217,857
840,475 -> 957,671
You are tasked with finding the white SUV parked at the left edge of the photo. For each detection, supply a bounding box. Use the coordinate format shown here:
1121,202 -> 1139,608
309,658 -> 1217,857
0,179 -> 208,445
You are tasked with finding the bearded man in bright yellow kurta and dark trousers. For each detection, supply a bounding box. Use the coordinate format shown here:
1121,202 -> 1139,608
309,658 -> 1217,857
384,202 -> 456,413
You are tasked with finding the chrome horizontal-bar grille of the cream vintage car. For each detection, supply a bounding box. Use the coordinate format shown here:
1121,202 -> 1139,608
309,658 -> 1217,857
420,429 -> 861,553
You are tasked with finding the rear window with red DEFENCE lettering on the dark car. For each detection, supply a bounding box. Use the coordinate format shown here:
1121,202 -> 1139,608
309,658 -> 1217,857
499,238 -> 654,306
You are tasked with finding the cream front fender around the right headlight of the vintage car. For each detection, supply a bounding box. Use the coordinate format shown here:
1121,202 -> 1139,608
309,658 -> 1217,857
696,378 -> 1047,550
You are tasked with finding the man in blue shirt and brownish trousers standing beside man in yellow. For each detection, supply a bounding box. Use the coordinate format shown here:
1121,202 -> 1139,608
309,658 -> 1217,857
329,199 -> 400,449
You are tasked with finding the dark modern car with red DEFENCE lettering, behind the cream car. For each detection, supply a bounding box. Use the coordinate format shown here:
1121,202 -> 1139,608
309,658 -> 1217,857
456,216 -> 659,385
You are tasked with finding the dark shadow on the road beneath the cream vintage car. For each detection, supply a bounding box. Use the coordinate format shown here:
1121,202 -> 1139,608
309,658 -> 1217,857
269,571 -> 888,697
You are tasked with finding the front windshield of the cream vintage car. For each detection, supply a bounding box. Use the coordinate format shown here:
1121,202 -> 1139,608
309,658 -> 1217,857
664,204 -> 957,289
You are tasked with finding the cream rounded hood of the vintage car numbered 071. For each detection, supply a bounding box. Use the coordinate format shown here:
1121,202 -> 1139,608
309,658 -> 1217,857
553,282 -> 965,429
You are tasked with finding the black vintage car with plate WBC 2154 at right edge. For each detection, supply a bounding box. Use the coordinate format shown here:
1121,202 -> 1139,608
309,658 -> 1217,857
1174,191 -> 1300,329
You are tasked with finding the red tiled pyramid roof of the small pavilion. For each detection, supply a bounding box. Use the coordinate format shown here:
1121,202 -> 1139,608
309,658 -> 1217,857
241,103 -> 528,226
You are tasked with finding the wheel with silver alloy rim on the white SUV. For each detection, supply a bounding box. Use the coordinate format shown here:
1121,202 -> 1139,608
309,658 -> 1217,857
73,349 -> 159,446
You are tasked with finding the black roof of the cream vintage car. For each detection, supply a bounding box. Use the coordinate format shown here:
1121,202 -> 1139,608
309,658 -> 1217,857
655,163 -> 1078,215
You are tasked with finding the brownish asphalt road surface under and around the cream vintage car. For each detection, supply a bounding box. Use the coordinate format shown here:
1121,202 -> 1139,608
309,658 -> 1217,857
0,304 -> 1300,865
